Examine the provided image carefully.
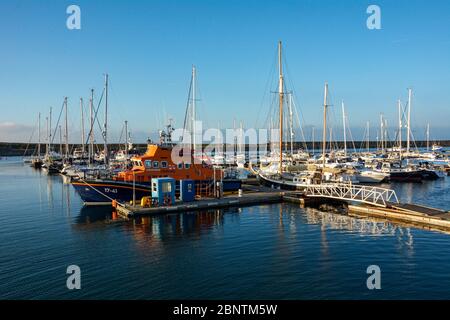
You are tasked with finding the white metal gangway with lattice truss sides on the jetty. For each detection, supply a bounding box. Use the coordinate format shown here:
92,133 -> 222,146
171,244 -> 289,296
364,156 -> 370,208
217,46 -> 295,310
305,183 -> 399,208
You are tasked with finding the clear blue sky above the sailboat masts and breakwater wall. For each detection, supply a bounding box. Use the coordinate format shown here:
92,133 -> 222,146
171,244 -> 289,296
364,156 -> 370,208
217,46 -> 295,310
0,0 -> 450,141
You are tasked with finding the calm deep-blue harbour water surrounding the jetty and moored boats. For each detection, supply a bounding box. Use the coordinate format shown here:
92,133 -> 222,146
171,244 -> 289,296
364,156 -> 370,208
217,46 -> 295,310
0,159 -> 450,299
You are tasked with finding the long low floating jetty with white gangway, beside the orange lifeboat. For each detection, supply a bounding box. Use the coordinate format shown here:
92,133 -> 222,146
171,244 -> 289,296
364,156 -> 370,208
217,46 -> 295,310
112,181 -> 450,231
